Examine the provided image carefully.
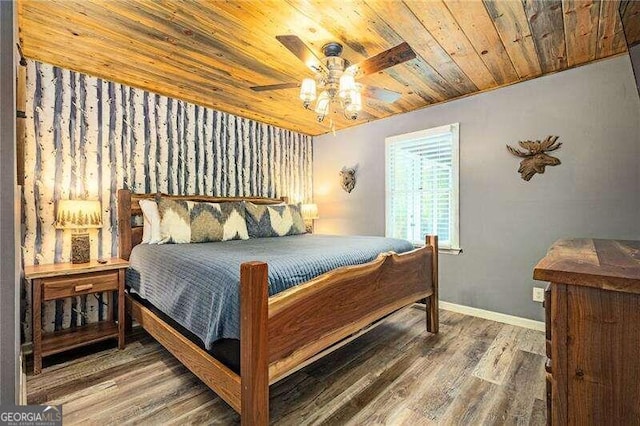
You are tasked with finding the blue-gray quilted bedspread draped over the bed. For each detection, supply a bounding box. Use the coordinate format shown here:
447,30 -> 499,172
127,234 -> 413,349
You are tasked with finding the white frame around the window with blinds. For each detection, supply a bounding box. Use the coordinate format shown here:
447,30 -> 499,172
384,123 -> 462,254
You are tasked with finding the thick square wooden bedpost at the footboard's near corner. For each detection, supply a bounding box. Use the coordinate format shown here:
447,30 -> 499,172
240,262 -> 269,426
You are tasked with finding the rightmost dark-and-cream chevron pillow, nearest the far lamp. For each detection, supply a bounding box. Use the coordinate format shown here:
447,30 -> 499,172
245,202 -> 306,238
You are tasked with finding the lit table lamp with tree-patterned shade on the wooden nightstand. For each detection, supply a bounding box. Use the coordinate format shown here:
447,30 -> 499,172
55,200 -> 102,263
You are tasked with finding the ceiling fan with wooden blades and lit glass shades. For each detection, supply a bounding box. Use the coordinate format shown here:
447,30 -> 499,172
251,35 -> 416,122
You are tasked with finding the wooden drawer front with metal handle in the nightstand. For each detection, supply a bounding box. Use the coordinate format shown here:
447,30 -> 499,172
42,270 -> 118,300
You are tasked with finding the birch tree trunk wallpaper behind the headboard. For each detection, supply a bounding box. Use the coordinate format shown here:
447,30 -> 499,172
22,61 -> 312,341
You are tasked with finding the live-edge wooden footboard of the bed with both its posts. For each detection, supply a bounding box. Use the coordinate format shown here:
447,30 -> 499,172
240,236 -> 438,412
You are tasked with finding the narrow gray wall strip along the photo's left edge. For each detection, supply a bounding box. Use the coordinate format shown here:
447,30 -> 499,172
0,1 -> 19,404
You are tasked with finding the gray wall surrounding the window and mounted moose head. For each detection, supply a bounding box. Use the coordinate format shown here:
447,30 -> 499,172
314,55 -> 640,320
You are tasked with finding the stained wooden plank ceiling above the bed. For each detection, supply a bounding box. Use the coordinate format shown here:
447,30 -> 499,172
18,0 -> 627,135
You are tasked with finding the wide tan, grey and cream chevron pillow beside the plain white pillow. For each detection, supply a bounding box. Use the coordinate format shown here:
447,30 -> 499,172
158,197 -> 249,244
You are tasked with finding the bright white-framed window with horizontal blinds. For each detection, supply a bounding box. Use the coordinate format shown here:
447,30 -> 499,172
385,123 -> 460,251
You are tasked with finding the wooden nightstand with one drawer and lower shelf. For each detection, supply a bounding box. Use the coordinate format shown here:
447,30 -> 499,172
24,258 -> 129,374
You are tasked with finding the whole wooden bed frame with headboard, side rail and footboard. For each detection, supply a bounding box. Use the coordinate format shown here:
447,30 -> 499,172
118,189 -> 438,425
